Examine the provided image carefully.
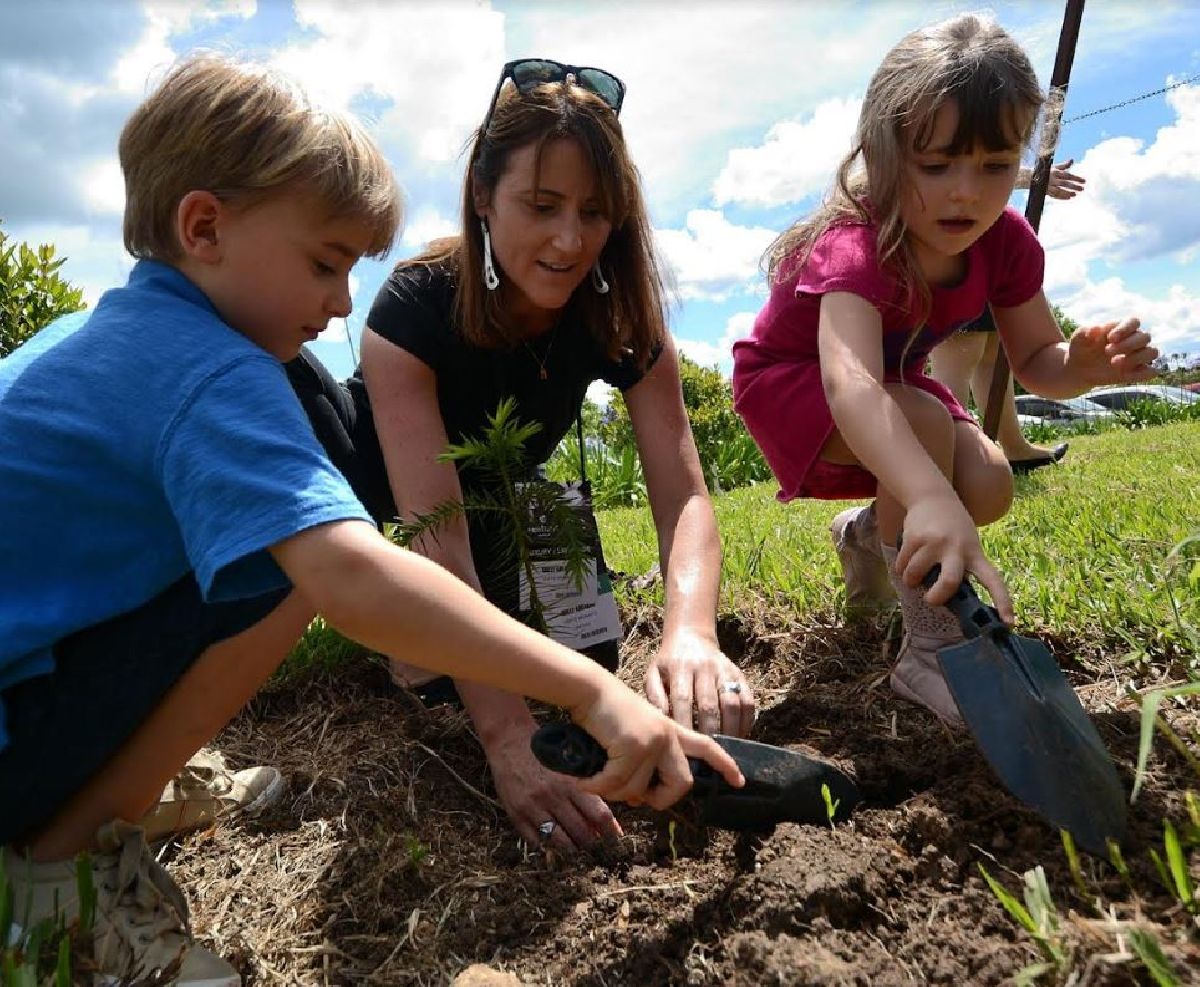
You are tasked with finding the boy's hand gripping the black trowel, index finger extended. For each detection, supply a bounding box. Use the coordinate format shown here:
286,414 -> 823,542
571,678 -> 745,809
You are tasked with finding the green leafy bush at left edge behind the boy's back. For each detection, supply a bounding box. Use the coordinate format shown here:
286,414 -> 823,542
0,222 -> 84,357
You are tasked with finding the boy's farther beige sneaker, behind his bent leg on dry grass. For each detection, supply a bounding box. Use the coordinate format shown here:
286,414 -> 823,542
138,749 -> 287,843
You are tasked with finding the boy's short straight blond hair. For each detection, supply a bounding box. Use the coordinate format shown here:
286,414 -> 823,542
118,54 -> 402,263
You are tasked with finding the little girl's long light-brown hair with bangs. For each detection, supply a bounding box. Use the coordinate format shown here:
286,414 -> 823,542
763,13 -> 1057,329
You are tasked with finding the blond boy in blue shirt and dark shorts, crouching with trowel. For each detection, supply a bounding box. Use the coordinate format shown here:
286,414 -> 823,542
0,56 -> 740,985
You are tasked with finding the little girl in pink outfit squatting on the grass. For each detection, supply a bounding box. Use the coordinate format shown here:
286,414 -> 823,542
733,14 -> 1157,724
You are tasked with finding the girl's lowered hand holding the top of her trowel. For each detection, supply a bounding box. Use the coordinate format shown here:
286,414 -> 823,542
896,497 -> 1015,624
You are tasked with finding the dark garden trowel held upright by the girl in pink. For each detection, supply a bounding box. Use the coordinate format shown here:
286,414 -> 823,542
923,566 -> 1126,859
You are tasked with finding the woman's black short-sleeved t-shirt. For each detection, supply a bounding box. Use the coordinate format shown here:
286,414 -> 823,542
348,264 -> 658,481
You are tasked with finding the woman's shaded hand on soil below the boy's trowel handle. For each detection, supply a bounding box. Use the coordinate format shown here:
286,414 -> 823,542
484,719 -> 622,850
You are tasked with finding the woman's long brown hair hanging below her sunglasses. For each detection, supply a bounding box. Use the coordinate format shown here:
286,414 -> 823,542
397,74 -> 666,367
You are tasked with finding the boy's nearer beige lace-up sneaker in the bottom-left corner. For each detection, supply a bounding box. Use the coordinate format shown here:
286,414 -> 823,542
4,820 -> 241,987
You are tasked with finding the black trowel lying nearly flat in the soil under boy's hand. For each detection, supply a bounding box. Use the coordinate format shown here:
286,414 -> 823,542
530,723 -> 862,832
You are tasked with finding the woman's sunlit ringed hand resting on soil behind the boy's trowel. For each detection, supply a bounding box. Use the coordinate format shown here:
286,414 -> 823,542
644,630 -> 755,737
